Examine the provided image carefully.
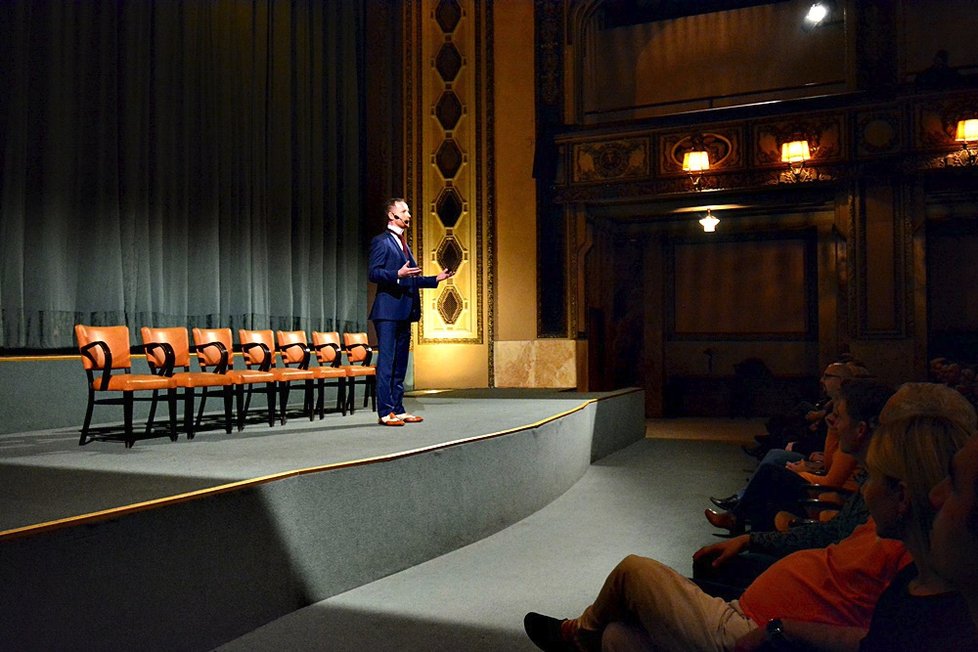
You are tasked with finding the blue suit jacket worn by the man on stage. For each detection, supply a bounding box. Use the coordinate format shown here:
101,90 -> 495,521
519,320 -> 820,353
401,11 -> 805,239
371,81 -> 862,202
369,231 -> 438,321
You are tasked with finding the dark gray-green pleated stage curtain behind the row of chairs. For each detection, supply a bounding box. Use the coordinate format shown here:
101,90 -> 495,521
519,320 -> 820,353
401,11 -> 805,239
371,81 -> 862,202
0,0 -> 367,349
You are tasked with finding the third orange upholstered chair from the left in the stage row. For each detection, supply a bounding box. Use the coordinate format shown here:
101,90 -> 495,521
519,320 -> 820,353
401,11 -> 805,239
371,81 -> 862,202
193,328 -> 277,430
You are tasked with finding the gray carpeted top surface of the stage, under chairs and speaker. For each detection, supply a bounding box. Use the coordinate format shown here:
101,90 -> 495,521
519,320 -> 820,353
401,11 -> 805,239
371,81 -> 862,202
0,389 -> 624,536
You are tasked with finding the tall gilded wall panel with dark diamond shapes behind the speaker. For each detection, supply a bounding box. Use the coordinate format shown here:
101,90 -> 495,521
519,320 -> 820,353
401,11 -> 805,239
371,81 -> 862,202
405,0 -> 491,343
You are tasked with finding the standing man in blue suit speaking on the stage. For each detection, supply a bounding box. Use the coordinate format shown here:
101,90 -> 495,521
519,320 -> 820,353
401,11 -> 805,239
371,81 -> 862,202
369,197 -> 455,426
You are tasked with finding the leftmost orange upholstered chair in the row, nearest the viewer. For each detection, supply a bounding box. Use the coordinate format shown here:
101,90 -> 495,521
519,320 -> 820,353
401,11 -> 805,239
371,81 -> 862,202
75,324 -> 177,448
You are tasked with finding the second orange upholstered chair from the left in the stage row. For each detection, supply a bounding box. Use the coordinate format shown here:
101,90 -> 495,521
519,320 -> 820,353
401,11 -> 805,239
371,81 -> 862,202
140,326 -> 234,439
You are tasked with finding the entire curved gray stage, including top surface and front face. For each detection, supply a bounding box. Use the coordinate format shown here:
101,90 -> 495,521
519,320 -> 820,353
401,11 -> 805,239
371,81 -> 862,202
0,390 -> 645,650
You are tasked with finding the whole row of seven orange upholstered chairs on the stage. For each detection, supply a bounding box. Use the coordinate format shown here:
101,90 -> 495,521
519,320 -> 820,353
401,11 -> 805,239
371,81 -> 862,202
75,324 -> 376,448
